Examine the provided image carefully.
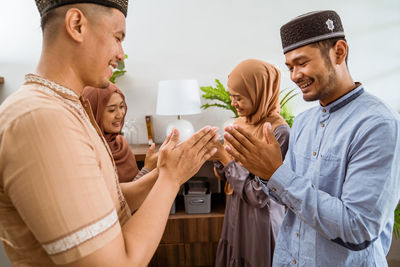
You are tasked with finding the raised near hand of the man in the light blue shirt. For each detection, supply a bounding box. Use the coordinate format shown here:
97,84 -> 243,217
224,122 -> 282,180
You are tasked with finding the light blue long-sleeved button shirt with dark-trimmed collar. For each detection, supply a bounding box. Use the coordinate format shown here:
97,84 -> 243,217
265,85 -> 400,267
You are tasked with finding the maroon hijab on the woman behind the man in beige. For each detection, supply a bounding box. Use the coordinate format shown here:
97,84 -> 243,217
82,83 -> 139,183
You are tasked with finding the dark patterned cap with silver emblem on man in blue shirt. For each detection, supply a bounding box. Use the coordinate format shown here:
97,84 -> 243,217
281,10 -> 345,54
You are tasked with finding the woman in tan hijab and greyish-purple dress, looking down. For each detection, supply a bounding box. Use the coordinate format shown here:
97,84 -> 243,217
213,59 -> 290,267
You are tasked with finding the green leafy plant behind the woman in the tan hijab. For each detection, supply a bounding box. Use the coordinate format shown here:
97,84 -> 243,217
200,79 -> 298,127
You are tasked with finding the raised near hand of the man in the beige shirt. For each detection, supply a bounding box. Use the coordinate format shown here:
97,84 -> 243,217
157,126 -> 218,186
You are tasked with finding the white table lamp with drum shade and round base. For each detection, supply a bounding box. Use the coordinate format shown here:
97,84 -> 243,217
156,80 -> 201,141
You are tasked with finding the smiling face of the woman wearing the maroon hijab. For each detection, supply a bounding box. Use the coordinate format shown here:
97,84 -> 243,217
103,92 -> 126,133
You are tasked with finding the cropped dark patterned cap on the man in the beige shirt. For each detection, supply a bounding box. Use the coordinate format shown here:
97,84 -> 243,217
35,0 -> 128,17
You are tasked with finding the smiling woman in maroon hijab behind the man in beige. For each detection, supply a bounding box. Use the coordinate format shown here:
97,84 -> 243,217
82,83 -> 157,183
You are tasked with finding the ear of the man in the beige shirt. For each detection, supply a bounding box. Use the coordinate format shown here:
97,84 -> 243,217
65,8 -> 88,43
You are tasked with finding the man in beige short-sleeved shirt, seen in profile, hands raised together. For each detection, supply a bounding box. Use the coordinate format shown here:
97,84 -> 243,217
0,0 -> 216,267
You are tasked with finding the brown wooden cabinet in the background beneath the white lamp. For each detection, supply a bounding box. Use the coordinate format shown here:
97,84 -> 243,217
132,144 -> 225,267
